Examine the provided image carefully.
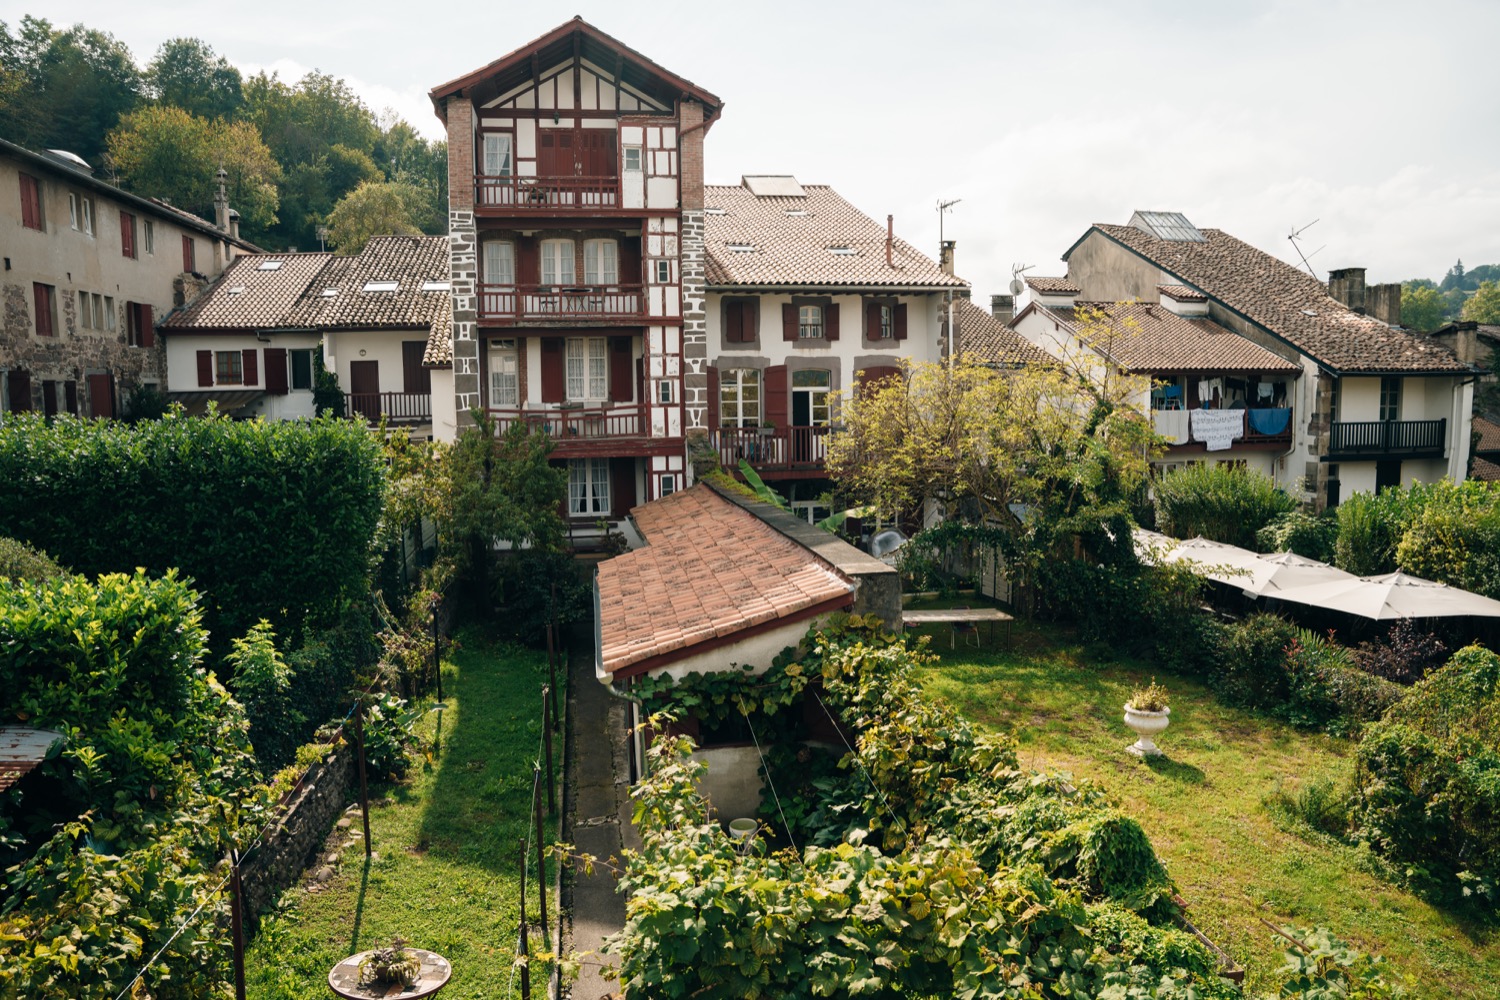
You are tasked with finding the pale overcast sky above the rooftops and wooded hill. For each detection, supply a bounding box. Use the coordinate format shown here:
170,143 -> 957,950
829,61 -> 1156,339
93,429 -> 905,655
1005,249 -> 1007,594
14,0 -> 1500,301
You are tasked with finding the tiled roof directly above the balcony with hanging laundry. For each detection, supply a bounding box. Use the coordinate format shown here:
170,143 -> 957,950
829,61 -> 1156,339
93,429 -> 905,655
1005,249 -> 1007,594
1046,303 -> 1301,373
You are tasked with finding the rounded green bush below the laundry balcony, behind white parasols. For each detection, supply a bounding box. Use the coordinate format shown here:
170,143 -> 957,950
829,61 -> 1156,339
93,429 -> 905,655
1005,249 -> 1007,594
1152,462 -> 1296,549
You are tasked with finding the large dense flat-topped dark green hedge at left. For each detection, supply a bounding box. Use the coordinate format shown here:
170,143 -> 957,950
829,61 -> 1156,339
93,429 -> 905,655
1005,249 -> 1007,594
0,414 -> 384,651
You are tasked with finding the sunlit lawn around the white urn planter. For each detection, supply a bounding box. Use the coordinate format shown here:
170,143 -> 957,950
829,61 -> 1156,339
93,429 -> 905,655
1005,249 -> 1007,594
906,622 -> 1500,999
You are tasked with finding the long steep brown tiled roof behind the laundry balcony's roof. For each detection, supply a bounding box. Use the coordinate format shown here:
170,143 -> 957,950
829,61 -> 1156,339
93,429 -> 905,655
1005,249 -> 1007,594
1086,223 -> 1470,373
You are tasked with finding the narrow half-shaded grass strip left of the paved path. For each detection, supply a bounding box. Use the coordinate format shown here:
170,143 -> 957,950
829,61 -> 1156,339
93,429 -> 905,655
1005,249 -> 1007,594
246,645 -> 563,1000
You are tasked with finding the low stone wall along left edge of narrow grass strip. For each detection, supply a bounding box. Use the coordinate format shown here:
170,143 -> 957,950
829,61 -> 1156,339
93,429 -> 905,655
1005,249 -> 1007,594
240,742 -> 359,924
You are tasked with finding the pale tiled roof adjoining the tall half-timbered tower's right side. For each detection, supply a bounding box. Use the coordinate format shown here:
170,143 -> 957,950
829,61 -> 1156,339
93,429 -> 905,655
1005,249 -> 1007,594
704,184 -> 968,289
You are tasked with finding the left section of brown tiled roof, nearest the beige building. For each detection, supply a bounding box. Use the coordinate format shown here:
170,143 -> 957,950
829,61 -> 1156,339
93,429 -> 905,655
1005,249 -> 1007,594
162,253 -> 333,330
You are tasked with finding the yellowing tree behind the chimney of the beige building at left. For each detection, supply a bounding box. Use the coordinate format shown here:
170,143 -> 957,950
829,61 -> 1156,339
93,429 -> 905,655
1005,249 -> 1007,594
110,105 -> 281,238
